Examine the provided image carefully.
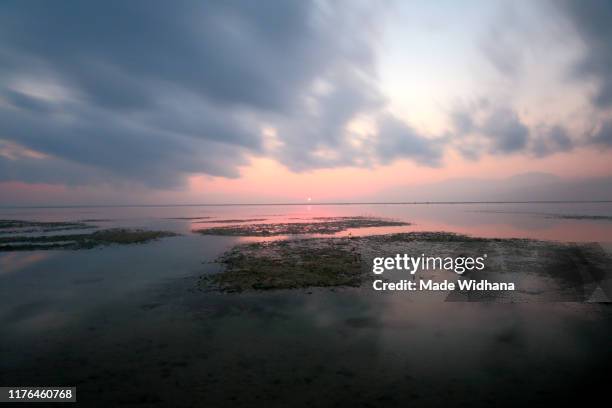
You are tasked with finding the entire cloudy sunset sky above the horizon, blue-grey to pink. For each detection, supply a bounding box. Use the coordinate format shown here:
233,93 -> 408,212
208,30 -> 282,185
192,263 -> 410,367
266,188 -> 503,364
0,0 -> 612,205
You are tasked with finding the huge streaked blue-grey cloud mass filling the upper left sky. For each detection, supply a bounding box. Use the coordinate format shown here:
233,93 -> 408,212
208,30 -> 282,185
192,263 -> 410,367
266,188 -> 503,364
0,0 -> 390,187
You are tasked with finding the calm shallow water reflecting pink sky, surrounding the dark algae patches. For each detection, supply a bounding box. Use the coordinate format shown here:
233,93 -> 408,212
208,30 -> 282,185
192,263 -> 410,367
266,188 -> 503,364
0,203 -> 612,406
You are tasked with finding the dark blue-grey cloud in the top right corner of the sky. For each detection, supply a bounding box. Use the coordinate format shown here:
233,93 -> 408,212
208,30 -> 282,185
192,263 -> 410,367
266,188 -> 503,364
555,0 -> 612,108
